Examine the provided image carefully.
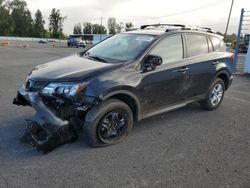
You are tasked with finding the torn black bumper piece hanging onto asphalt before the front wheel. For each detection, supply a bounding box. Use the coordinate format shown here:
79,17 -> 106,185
25,120 -> 77,154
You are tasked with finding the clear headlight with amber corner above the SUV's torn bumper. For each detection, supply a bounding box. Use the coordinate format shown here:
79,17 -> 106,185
42,82 -> 88,97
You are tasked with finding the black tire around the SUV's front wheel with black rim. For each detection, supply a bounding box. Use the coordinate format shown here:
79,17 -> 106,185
84,99 -> 133,147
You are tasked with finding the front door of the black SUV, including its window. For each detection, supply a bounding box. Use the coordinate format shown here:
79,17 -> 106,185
139,34 -> 189,114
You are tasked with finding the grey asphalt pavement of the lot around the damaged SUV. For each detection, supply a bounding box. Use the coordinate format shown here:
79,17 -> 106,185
0,45 -> 250,188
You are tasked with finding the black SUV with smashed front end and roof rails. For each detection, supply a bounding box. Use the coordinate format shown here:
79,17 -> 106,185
14,24 -> 233,152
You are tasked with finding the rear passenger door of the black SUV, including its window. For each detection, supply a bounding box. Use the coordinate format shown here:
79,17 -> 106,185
185,33 -> 218,98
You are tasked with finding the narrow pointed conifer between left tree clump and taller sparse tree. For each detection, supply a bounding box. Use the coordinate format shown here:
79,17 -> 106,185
34,9 -> 46,37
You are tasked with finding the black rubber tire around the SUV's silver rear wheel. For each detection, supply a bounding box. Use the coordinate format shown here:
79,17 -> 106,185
200,78 -> 225,111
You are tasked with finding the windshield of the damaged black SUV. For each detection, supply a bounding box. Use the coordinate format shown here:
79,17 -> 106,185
84,33 -> 155,63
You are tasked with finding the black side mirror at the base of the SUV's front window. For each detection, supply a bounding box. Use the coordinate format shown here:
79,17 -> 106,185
142,55 -> 163,72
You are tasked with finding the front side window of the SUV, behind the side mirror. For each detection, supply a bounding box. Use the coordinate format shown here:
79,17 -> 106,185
150,35 -> 183,64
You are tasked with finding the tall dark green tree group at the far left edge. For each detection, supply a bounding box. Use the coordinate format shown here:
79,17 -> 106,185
0,0 -> 66,38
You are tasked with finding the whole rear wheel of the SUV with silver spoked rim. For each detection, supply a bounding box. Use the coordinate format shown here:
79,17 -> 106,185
200,78 -> 225,110
